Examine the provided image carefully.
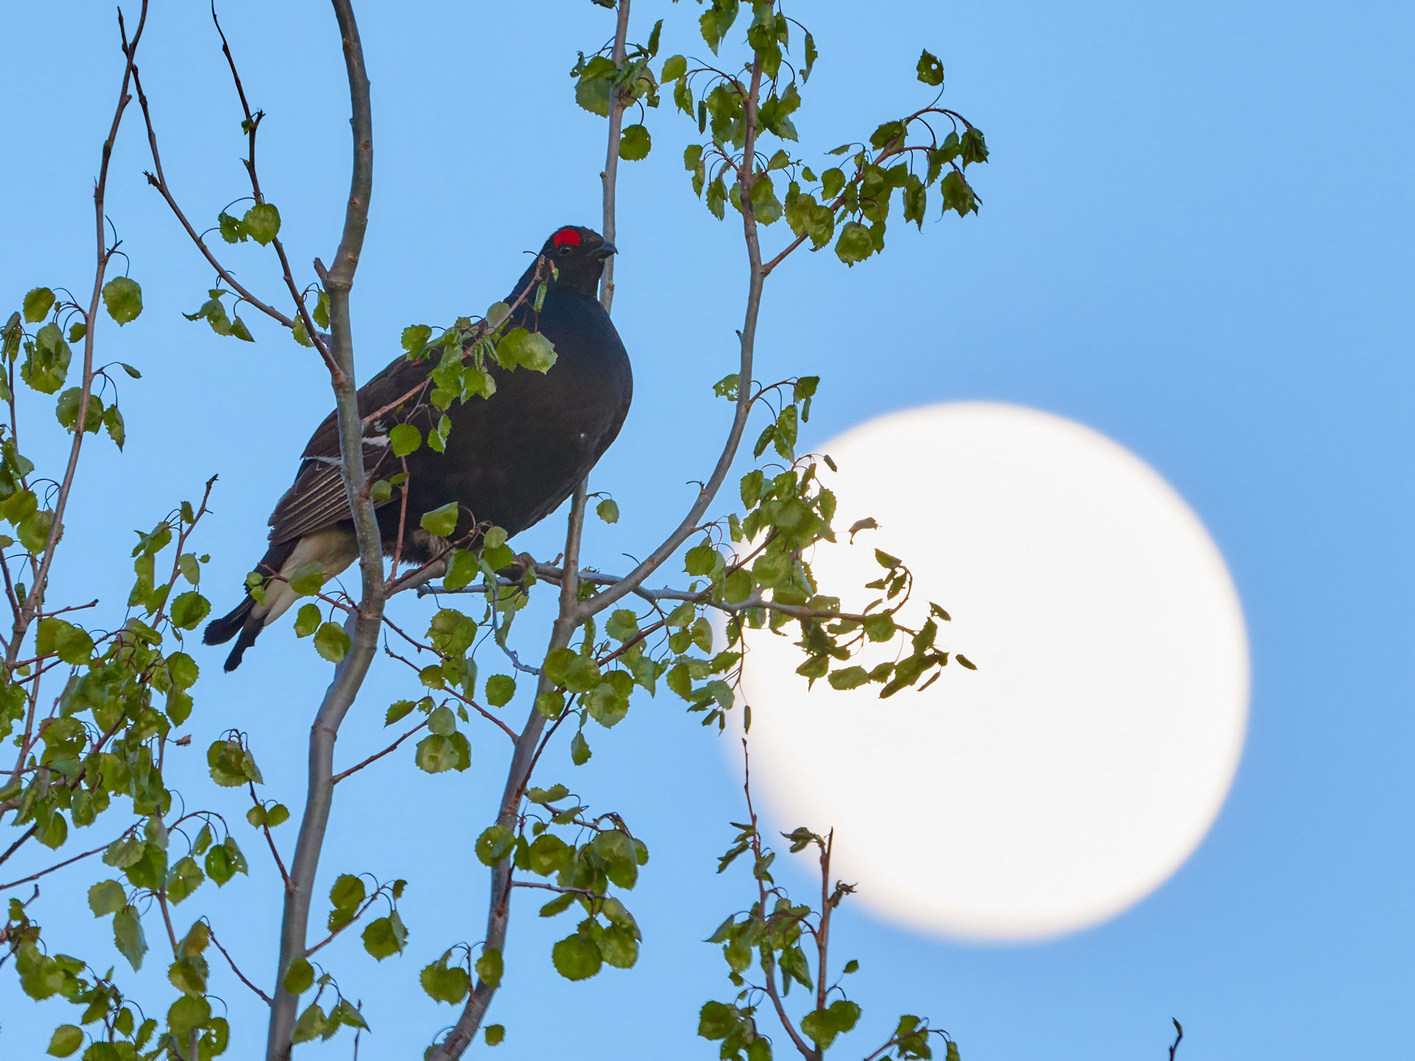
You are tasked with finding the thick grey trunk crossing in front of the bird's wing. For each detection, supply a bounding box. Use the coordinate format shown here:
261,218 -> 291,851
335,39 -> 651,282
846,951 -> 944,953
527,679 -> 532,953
266,0 -> 385,1061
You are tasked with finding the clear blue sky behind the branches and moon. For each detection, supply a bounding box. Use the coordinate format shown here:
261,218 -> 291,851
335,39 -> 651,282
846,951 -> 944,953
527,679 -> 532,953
0,0 -> 1415,1061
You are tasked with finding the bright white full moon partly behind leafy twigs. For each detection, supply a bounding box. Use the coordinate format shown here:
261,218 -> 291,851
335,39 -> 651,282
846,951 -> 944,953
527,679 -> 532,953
729,403 -> 1248,941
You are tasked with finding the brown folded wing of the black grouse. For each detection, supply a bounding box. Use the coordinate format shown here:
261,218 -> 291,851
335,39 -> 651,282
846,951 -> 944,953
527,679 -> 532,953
270,358 -> 432,543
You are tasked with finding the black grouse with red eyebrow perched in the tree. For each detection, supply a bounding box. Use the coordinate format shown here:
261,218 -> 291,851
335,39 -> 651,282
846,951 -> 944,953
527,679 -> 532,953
202,226 -> 634,671
